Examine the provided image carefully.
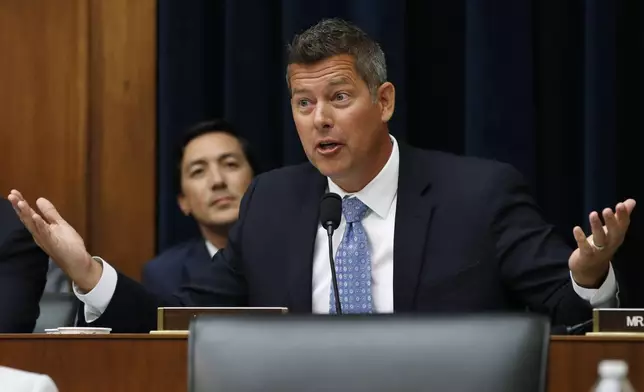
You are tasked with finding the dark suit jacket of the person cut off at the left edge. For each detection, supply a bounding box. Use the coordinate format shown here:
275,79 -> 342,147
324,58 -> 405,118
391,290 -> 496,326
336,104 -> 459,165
0,199 -> 49,333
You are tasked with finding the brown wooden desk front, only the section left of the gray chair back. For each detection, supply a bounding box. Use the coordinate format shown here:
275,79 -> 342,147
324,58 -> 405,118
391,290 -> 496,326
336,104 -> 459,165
0,335 -> 188,392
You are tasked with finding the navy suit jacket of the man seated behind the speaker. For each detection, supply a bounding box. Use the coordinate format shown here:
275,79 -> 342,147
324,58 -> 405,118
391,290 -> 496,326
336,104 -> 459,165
141,238 -> 212,299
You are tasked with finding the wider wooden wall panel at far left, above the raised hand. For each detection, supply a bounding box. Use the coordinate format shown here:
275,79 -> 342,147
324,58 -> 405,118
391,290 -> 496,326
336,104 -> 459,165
0,0 -> 88,235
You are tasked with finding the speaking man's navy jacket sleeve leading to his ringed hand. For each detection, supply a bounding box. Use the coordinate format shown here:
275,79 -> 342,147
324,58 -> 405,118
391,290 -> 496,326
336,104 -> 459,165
490,167 -> 592,325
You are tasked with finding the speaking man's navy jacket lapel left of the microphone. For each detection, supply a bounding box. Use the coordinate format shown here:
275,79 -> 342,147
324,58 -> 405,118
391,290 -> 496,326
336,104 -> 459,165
285,166 -> 327,313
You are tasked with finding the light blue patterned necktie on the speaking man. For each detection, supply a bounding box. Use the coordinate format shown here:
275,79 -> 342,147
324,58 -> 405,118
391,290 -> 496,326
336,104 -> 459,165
329,197 -> 373,314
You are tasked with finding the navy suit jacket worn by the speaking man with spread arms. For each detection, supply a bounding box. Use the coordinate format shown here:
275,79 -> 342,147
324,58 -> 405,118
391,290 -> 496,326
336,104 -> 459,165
88,144 -> 591,332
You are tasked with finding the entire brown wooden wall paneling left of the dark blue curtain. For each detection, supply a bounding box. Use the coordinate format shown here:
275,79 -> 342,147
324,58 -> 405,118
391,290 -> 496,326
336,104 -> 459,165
0,0 -> 156,278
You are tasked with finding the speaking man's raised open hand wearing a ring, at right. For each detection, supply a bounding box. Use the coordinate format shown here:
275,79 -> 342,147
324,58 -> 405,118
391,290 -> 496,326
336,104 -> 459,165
568,199 -> 635,288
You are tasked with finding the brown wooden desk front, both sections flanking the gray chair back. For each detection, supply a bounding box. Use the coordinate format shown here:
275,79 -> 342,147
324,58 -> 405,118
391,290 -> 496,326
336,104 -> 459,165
0,334 -> 644,392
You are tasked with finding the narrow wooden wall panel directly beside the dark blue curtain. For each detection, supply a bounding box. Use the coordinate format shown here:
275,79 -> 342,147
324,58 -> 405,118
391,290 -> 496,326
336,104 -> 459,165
88,0 -> 156,278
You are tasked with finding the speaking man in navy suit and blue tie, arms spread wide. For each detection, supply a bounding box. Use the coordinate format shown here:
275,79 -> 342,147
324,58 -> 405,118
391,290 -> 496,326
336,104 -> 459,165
10,19 -> 635,332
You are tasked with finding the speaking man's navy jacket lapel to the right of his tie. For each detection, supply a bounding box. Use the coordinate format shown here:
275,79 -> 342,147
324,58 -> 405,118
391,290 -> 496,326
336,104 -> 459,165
394,144 -> 435,313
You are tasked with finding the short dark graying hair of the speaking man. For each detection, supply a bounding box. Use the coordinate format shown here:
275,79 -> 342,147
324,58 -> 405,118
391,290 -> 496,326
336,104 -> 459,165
286,18 -> 387,97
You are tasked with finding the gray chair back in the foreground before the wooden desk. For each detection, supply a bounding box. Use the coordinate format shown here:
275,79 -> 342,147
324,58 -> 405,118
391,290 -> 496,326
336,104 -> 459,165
189,314 -> 550,392
